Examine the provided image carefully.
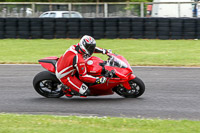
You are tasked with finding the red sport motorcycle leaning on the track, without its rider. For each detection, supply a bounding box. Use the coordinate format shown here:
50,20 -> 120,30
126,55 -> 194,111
33,53 -> 145,98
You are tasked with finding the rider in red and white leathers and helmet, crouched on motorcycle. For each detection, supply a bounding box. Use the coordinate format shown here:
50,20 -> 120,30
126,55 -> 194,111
56,35 -> 111,97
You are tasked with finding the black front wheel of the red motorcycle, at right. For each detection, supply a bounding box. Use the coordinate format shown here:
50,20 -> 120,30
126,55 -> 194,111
114,77 -> 145,98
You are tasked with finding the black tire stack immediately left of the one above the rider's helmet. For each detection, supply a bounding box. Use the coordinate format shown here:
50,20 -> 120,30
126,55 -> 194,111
68,18 -> 80,38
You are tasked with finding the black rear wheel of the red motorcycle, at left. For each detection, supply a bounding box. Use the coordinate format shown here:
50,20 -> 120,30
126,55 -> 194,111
33,71 -> 64,98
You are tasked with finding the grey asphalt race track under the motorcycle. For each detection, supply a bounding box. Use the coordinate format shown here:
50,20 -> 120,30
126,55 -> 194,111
0,65 -> 200,120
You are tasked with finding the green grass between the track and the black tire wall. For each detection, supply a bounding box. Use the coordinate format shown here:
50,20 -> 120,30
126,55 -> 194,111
0,39 -> 200,66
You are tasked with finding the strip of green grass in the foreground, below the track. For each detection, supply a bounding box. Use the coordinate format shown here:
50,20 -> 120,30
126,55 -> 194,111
0,114 -> 200,133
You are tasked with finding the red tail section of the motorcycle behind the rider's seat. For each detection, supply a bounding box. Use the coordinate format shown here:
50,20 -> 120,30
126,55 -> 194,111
39,56 -> 59,73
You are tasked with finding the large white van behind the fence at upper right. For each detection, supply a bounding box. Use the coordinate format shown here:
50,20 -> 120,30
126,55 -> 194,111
151,0 -> 194,17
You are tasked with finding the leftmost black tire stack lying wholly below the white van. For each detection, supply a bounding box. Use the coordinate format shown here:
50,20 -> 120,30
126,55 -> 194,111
157,18 -> 170,39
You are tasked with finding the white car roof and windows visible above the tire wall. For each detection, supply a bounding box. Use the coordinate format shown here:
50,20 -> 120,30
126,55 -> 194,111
39,11 -> 82,18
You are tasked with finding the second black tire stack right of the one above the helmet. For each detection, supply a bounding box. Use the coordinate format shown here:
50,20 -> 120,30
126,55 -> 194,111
105,18 -> 118,39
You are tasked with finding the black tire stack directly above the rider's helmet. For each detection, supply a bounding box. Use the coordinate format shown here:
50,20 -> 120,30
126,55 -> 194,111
79,18 -> 93,37
